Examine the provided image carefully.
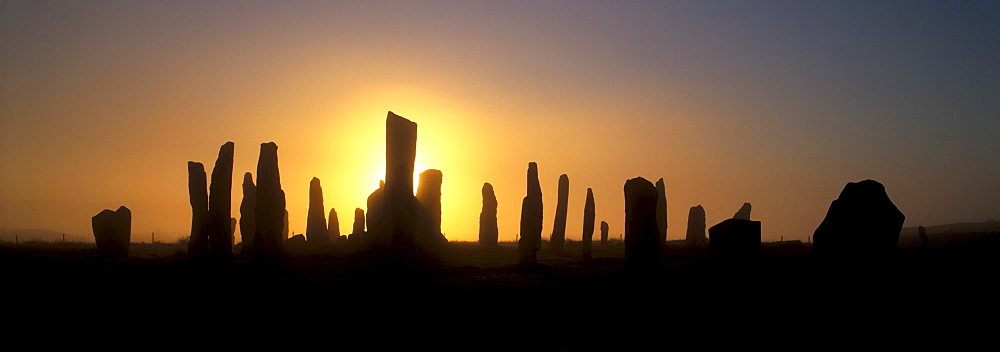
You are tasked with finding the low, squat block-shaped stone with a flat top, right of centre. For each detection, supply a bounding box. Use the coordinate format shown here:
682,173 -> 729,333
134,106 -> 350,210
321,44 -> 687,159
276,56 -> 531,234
708,217 -> 761,260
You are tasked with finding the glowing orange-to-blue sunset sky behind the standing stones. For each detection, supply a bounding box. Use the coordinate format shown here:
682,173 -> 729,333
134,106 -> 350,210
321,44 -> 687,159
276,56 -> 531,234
0,1 -> 1000,241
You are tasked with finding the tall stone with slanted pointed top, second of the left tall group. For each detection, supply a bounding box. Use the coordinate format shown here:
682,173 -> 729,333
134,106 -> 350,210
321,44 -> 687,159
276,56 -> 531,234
207,142 -> 233,261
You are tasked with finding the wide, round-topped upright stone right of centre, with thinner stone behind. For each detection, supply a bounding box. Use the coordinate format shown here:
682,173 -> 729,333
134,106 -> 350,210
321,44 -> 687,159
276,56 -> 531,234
624,177 -> 661,266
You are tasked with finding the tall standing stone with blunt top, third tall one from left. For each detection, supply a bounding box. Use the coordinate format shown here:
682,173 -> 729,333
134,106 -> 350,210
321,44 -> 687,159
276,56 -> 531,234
253,142 -> 288,263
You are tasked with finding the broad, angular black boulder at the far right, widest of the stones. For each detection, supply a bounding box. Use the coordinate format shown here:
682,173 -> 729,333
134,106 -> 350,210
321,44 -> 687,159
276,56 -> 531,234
813,180 -> 905,257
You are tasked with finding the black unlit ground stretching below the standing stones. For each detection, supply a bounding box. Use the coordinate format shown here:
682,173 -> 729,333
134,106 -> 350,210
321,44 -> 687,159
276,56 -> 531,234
0,234 -> 1000,351
